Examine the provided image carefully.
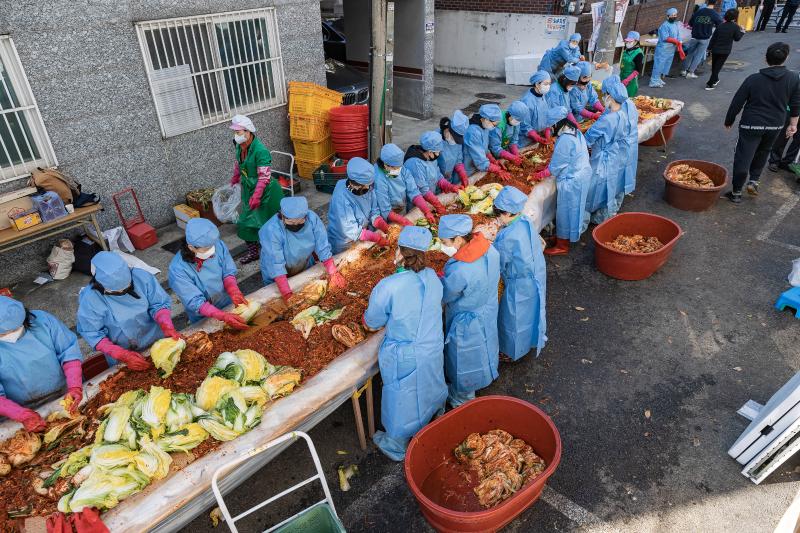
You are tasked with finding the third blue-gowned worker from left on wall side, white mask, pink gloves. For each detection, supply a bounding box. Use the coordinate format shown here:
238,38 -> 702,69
168,218 -> 247,330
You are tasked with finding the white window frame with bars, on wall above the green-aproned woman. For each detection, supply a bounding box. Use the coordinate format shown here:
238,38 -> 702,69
136,7 -> 287,138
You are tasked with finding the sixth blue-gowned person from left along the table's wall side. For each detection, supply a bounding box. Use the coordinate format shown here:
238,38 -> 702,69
374,144 -> 424,226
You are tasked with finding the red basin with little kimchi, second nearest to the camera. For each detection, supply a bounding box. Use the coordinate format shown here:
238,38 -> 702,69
592,213 -> 683,281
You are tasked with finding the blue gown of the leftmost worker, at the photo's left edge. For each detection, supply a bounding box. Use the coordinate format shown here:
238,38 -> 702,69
0,311 -> 82,405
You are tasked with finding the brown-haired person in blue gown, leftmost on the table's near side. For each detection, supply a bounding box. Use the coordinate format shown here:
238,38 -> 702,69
364,226 -> 447,461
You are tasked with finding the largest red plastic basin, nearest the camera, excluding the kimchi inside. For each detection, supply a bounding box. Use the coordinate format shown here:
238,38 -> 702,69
404,396 -> 561,533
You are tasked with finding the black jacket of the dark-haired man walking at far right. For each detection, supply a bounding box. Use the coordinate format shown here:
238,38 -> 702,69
725,66 -> 800,130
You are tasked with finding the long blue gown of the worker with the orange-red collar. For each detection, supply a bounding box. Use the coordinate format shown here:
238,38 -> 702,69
442,239 -> 500,404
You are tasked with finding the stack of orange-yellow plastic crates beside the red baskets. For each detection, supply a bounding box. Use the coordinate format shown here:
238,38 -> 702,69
289,81 -> 342,179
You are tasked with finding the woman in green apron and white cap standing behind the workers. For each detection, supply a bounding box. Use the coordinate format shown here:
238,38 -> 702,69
230,115 -> 283,264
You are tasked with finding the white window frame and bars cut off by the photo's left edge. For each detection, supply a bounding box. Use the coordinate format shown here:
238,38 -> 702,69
0,35 -> 58,185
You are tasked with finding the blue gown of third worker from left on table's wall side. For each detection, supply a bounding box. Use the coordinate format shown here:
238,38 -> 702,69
169,240 -> 236,323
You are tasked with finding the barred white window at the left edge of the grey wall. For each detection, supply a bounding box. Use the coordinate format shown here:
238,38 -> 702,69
0,35 -> 57,184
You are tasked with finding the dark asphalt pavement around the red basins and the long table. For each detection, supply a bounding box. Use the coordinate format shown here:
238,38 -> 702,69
184,29 -> 800,533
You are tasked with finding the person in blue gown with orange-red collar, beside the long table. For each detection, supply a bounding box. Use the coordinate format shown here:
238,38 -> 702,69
439,215 -> 500,407
